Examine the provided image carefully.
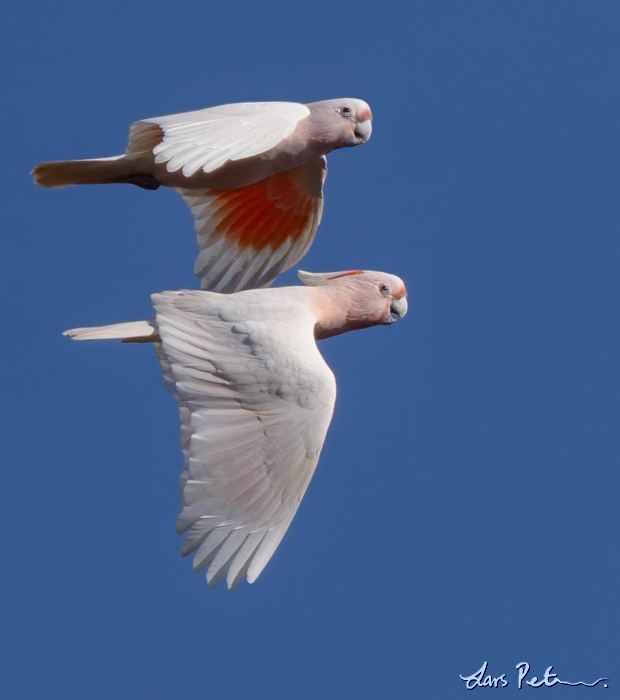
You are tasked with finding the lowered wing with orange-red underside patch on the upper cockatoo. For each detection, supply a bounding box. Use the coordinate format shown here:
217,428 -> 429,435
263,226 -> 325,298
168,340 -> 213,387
177,157 -> 327,292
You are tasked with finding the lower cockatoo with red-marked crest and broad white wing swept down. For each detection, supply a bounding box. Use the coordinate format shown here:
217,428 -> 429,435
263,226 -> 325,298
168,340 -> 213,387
65,270 -> 407,590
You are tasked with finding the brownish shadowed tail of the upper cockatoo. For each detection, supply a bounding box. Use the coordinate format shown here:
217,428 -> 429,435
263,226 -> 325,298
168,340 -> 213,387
30,156 -> 145,188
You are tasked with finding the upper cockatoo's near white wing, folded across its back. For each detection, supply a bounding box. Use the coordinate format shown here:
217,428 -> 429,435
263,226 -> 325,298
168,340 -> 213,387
126,102 -> 310,177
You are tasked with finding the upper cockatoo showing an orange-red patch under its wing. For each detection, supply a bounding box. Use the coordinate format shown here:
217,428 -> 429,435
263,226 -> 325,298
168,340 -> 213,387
32,98 -> 372,292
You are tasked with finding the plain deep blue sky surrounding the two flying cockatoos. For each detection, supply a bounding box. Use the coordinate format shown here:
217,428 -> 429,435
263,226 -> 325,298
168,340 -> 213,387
0,0 -> 620,700
